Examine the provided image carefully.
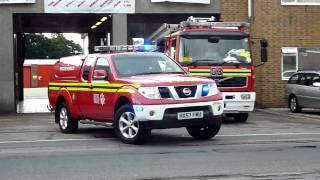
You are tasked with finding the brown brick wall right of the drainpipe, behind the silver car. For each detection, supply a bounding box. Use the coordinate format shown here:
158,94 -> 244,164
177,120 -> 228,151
251,0 -> 320,107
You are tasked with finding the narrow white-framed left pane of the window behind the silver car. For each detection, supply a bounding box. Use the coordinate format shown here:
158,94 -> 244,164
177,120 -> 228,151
281,48 -> 298,80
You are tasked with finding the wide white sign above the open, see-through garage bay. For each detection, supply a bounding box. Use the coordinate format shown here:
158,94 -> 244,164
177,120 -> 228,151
44,0 -> 135,14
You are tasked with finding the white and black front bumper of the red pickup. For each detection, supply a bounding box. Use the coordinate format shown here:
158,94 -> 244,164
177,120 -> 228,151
133,101 -> 224,128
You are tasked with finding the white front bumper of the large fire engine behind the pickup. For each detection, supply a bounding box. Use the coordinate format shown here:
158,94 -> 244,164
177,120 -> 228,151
222,92 -> 256,113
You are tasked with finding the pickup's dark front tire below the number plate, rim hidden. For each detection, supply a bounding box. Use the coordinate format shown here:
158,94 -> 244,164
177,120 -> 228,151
186,117 -> 222,140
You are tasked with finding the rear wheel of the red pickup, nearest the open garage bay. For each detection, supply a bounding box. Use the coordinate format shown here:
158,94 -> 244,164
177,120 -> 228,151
55,102 -> 79,134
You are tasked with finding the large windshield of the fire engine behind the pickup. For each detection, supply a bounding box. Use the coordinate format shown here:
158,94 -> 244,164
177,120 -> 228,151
179,35 -> 251,65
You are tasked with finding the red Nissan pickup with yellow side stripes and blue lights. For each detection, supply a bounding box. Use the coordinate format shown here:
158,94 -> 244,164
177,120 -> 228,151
48,46 -> 223,144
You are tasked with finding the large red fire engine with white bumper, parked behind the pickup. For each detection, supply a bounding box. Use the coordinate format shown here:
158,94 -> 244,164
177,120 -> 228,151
148,16 -> 268,122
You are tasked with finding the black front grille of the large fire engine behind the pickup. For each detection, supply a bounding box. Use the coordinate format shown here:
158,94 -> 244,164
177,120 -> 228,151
212,77 -> 248,88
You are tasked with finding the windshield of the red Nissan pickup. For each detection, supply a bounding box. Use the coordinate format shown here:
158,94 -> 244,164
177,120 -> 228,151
112,53 -> 185,76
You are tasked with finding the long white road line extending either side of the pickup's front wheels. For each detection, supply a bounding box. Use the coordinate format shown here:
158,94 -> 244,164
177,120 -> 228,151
0,133 -> 320,144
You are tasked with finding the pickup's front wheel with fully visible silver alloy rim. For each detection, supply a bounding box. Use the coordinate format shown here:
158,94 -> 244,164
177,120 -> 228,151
114,105 -> 151,144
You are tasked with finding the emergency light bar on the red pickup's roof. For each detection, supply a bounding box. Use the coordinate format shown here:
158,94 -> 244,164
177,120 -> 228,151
94,45 -> 156,52
